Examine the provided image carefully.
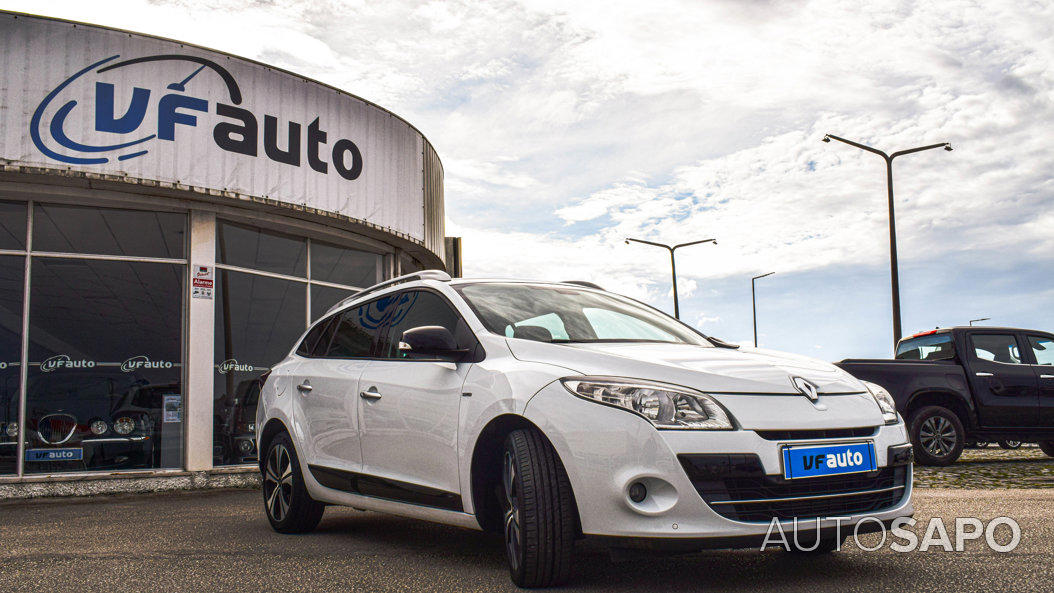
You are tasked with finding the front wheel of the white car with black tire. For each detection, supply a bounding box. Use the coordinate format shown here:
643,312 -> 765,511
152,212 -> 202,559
501,429 -> 577,588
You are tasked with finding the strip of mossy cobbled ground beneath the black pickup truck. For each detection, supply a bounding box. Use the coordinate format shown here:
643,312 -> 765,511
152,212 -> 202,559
915,444 -> 1054,488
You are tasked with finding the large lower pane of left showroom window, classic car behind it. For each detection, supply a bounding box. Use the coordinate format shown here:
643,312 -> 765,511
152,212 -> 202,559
25,258 -> 186,473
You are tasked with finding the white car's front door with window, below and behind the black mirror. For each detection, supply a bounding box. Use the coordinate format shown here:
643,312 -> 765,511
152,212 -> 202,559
359,291 -> 474,511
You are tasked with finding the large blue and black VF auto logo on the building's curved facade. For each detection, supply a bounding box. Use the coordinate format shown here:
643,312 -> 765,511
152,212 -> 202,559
30,55 -> 363,180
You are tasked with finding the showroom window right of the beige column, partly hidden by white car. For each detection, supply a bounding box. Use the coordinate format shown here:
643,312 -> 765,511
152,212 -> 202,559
213,220 -> 385,466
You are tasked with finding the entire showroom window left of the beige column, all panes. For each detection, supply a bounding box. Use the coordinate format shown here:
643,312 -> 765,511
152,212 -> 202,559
0,202 -> 187,474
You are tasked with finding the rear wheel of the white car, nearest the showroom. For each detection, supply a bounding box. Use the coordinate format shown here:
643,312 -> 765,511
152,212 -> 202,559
262,433 -> 326,533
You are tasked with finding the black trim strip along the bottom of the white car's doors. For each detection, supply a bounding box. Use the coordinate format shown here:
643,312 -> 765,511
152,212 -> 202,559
308,464 -> 465,513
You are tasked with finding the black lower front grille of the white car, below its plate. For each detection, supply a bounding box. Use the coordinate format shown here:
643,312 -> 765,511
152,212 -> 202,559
678,454 -> 909,522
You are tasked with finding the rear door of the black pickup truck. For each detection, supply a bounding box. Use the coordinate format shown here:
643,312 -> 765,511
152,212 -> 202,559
962,331 -> 1039,428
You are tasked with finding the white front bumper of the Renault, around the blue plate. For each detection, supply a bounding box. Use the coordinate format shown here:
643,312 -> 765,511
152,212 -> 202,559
524,381 -> 914,542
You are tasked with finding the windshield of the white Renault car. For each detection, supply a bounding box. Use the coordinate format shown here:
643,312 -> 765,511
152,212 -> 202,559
456,282 -> 713,347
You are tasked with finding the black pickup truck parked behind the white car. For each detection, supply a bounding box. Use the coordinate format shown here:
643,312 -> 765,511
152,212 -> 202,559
837,327 -> 1054,466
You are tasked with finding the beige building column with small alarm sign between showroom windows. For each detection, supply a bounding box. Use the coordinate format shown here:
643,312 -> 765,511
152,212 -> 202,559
183,211 -> 216,472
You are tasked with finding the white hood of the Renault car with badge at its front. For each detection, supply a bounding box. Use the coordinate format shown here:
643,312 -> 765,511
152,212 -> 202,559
507,338 -> 883,430
